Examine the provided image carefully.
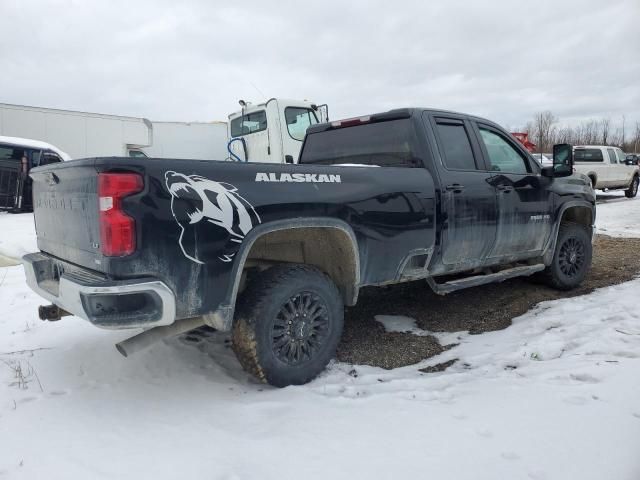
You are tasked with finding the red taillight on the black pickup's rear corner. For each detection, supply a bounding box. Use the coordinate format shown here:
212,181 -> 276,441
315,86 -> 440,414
98,173 -> 143,257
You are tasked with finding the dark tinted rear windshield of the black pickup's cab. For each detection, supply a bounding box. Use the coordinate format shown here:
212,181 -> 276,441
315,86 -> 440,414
299,118 -> 418,167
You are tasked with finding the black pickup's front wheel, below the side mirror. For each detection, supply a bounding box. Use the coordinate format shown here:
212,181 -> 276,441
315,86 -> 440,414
541,222 -> 593,290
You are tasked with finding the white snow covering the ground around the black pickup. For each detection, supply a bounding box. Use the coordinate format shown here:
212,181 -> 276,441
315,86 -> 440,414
0,196 -> 640,480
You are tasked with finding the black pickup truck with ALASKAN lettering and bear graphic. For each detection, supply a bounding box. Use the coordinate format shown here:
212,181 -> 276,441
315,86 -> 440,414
24,109 -> 595,386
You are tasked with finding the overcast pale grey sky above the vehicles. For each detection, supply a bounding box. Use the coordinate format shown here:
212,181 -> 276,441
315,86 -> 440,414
0,0 -> 640,126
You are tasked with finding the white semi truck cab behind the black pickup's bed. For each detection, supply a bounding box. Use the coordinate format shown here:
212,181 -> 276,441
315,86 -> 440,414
227,98 -> 329,163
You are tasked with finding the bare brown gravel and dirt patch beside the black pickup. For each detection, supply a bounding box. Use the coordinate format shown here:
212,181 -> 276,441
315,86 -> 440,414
338,235 -> 640,369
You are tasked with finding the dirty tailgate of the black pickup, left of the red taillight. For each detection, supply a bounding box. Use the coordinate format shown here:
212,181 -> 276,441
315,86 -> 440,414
31,159 -> 101,270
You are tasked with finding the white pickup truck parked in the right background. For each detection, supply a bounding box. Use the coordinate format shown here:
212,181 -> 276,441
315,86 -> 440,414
573,145 -> 640,198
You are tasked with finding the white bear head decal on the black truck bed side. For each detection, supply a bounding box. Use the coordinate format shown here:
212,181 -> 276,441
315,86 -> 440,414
165,171 -> 260,264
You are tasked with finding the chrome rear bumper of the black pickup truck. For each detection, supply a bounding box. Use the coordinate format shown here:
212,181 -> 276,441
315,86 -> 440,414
22,253 -> 176,329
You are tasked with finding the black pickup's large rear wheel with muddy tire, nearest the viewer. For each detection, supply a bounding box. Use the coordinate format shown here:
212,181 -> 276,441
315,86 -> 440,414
232,264 -> 344,387
